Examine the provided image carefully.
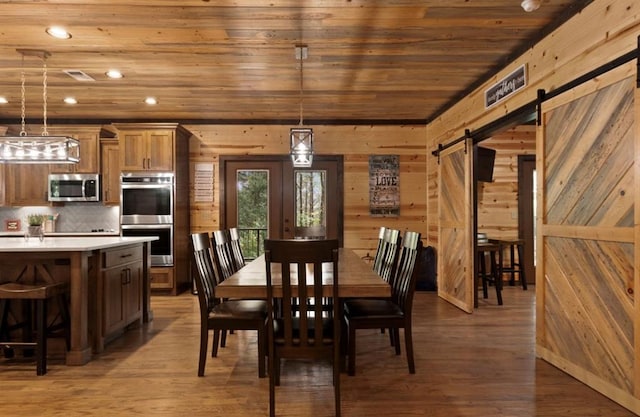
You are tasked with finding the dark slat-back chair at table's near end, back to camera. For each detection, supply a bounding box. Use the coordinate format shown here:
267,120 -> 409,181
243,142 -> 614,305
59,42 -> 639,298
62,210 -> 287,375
264,239 -> 341,417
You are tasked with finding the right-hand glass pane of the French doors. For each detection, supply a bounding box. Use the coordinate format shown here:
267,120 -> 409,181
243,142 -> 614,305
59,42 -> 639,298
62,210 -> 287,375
294,170 -> 327,239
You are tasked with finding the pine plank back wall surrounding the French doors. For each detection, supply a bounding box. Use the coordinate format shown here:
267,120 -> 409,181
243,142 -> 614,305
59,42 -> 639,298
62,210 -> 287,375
185,125 -> 427,256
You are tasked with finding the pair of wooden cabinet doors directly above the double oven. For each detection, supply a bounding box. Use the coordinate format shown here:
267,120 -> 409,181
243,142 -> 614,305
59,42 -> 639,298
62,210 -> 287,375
120,128 -> 175,172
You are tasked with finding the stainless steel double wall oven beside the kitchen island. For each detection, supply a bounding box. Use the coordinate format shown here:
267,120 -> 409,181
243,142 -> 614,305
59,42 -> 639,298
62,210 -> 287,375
120,172 -> 175,266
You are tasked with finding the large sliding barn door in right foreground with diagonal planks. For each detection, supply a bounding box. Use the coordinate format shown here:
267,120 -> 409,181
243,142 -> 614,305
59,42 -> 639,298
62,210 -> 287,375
536,65 -> 640,411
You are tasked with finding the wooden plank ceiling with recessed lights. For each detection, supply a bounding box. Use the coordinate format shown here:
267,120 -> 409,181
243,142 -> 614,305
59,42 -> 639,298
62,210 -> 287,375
0,0 -> 589,124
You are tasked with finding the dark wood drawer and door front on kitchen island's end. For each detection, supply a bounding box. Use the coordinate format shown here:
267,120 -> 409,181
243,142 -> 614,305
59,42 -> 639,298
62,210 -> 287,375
101,245 -> 143,340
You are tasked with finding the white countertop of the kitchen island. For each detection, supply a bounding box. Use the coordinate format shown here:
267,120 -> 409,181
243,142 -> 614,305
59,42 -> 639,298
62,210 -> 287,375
0,236 -> 158,252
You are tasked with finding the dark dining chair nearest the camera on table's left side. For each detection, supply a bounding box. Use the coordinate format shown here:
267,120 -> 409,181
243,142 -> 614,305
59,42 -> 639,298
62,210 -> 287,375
191,233 -> 267,378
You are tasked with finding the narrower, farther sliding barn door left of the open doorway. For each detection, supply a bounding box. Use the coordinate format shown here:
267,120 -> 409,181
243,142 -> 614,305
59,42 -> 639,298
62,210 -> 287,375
438,140 -> 474,313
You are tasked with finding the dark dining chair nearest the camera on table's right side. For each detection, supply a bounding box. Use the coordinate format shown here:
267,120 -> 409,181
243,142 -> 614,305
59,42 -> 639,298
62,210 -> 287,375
344,232 -> 422,375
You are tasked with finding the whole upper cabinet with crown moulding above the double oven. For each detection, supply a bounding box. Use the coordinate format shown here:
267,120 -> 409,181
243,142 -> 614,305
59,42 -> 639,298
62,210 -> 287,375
115,124 -> 188,172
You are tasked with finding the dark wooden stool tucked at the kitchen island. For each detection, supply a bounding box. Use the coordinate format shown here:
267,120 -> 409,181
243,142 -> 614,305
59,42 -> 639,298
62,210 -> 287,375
0,282 -> 70,375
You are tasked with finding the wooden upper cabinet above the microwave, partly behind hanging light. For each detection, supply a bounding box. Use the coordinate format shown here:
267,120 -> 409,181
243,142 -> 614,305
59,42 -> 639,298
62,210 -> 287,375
48,126 -> 114,174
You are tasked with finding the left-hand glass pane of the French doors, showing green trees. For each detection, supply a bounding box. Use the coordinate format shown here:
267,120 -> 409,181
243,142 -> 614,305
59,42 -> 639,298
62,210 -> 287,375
236,170 -> 269,260
